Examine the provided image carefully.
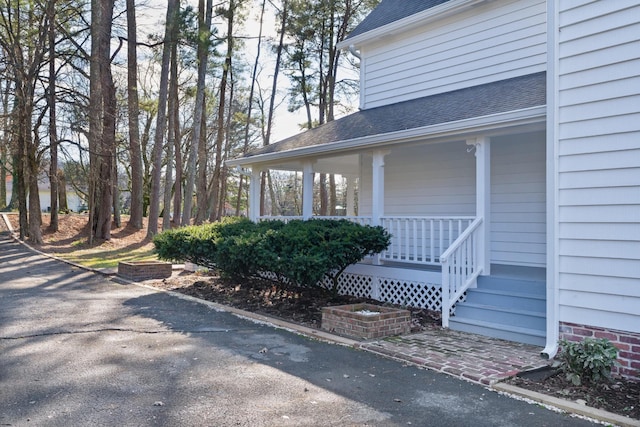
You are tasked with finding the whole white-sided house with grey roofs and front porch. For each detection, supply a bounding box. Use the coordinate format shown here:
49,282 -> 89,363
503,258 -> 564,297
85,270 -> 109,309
228,0 -> 640,377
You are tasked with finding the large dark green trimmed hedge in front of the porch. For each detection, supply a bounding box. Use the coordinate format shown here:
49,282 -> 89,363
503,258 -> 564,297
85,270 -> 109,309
153,218 -> 391,291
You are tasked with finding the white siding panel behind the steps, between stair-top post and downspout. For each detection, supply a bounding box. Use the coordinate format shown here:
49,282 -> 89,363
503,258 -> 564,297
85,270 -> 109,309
491,133 -> 546,267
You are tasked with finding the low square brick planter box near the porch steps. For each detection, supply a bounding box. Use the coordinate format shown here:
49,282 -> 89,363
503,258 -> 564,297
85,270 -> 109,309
322,304 -> 411,339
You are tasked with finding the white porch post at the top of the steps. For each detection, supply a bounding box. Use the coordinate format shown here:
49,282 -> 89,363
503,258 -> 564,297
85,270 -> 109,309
467,137 -> 491,276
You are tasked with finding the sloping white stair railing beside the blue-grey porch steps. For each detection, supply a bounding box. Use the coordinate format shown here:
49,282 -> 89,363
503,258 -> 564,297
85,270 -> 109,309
440,218 -> 482,328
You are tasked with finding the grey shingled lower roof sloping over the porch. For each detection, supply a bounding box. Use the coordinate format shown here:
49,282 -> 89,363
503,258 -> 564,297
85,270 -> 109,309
227,72 -> 546,165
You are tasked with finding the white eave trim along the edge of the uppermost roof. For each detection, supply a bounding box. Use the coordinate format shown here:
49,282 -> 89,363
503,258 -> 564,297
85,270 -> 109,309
336,0 -> 490,49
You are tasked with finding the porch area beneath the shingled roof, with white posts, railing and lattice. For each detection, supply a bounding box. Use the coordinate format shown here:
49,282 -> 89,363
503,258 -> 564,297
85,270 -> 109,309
238,129 -> 545,344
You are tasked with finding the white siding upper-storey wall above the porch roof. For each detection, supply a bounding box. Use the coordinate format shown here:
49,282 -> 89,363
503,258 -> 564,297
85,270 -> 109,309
360,0 -> 546,108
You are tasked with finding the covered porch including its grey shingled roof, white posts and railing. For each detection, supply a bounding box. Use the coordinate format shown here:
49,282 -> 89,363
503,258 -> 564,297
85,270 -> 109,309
228,74 -> 546,344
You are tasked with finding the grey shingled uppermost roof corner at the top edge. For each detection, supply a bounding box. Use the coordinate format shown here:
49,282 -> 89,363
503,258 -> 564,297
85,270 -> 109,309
346,0 -> 450,40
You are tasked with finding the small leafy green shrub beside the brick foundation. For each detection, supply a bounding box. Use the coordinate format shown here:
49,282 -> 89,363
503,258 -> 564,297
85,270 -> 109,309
557,338 -> 618,385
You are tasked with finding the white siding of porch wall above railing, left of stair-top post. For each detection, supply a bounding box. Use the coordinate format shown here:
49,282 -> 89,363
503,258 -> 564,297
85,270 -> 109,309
358,142 -> 476,216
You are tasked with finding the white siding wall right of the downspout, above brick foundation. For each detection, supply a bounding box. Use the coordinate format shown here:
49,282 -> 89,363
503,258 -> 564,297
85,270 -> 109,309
551,0 -> 640,333
